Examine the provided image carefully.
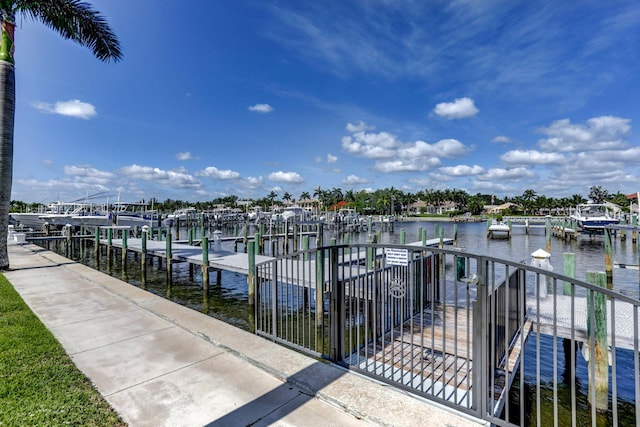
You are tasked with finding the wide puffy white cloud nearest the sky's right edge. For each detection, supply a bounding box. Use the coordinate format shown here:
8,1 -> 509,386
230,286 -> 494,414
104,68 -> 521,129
539,116 -> 631,151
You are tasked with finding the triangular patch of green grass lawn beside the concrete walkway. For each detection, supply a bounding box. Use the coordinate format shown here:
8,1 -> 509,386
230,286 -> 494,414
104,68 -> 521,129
0,274 -> 126,426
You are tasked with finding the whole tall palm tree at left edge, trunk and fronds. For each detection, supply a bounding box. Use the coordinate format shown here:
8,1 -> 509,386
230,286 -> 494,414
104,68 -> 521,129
0,0 -> 122,270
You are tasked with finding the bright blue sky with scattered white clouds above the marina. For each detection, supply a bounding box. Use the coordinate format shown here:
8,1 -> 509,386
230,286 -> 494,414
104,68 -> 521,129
12,0 -> 640,202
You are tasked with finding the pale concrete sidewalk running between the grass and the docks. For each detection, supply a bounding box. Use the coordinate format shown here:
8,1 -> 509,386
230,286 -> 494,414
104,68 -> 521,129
5,244 -> 481,427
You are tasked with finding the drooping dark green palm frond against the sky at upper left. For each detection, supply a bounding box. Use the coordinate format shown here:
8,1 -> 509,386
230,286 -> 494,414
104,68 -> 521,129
15,0 -> 122,62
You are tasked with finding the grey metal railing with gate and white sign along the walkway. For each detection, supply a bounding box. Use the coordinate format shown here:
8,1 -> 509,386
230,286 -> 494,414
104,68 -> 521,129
254,244 -> 640,426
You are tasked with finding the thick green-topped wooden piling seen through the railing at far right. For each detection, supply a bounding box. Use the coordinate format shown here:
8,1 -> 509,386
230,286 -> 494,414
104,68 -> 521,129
587,271 -> 609,412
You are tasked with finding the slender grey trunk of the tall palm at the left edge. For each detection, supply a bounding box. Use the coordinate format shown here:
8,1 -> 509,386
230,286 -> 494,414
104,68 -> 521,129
0,60 -> 16,270
